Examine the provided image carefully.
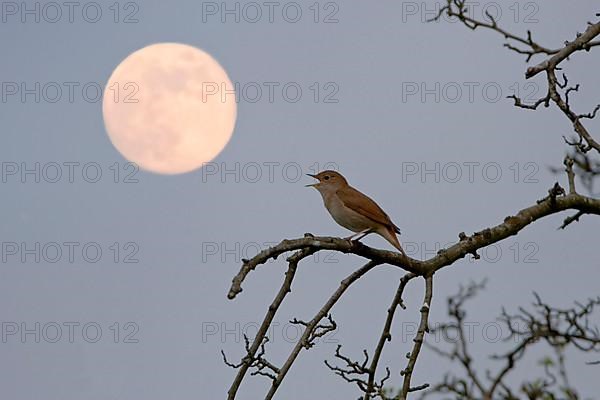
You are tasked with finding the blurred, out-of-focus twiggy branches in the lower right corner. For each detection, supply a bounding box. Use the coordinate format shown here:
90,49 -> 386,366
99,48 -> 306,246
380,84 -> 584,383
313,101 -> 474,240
421,284 -> 600,400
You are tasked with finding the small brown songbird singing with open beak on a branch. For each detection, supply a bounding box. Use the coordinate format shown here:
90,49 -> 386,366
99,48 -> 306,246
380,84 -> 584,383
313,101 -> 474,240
306,171 -> 405,254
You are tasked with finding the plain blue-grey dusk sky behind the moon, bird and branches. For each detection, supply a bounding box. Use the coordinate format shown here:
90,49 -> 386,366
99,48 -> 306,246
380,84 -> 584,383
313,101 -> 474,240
0,0 -> 600,400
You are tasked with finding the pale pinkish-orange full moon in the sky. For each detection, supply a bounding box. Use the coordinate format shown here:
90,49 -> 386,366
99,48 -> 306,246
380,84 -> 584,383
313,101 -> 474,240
102,43 -> 237,174
